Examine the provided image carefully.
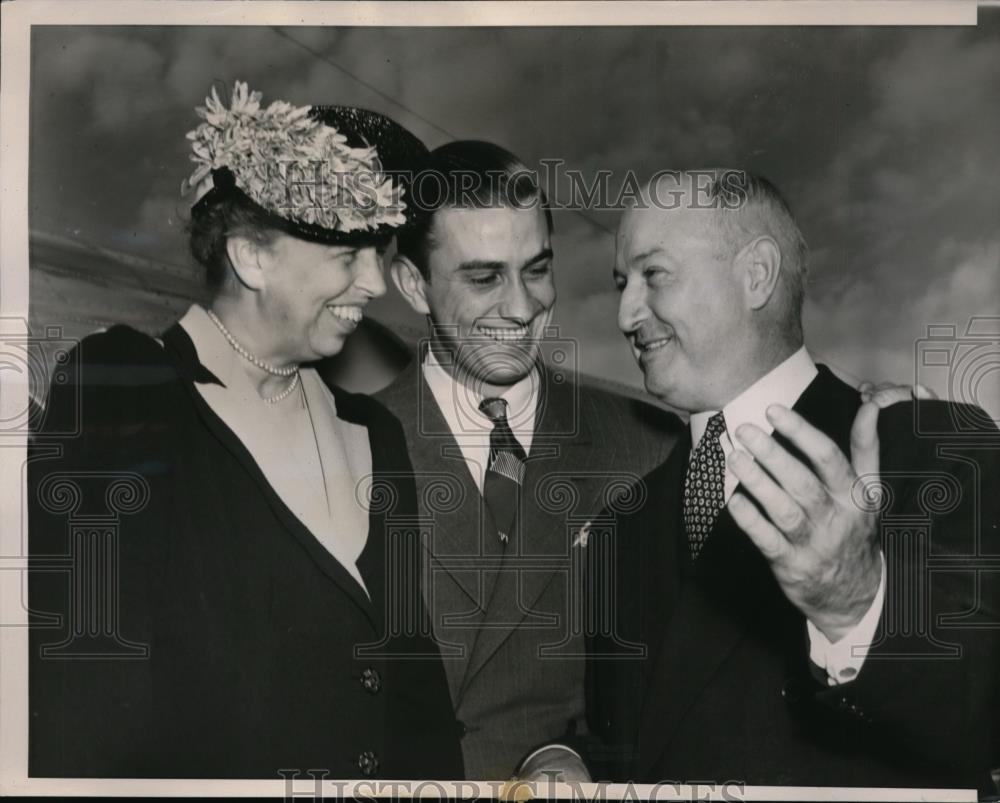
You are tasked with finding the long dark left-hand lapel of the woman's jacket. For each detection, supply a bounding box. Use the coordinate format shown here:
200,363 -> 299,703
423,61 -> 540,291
162,324 -> 381,630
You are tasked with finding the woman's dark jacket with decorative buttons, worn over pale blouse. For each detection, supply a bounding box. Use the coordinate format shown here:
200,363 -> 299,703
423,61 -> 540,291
29,326 -> 462,779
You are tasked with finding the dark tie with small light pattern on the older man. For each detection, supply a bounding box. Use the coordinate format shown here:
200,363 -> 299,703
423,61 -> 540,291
684,413 -> 726,560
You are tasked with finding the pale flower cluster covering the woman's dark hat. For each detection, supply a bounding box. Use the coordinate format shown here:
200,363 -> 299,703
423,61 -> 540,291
181,81 -> 406,232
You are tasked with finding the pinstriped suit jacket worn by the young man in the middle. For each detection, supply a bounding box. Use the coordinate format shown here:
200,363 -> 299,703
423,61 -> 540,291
376,360 -> 680,779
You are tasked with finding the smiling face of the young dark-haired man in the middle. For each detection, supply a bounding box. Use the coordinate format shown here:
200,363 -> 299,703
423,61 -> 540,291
414,204 -> 556,392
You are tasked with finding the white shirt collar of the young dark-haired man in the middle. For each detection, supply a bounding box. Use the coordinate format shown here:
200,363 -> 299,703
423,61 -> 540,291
423,349 -> 540,454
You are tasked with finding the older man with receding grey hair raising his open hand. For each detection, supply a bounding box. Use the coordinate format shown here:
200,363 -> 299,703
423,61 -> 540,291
588,171 -> 1000,791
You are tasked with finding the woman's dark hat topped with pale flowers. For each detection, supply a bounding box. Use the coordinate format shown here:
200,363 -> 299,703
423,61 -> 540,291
181,81 -> 427,245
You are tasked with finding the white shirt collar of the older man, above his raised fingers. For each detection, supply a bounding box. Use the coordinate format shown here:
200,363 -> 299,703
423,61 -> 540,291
691,346 -> 818,446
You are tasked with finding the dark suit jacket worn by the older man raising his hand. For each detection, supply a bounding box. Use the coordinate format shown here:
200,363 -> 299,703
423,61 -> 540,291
588,367 -> 1000,789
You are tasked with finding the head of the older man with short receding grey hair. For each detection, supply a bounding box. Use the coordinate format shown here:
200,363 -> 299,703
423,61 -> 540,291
615,170 -> 806,411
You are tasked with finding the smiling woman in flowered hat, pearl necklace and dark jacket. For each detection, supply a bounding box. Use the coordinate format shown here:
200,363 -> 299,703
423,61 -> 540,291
29,83 -> 462,779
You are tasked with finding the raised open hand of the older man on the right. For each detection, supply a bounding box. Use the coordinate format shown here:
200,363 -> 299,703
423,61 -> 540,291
729,400 -> 882,642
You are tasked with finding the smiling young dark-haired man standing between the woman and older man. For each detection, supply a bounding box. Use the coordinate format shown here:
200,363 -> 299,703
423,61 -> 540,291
378,142 -> 680,779
